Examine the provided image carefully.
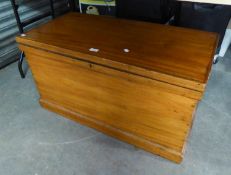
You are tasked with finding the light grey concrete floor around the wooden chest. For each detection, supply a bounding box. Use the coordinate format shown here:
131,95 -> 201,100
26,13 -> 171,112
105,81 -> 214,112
0,51 -> 231,175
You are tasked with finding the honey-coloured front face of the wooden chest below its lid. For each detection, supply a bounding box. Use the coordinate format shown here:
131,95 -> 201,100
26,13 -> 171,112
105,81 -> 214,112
22,46 -> 198,162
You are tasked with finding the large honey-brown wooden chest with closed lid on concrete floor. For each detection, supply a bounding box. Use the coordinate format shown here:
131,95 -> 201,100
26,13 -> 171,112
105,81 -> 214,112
17,13 -> 218,162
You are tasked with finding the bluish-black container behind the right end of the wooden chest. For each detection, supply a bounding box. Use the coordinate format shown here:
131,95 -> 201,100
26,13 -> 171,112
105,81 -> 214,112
178,2 -> 231,46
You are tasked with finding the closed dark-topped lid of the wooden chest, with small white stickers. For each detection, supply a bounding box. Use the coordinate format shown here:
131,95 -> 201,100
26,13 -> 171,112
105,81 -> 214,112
17,13 -> 218,91
